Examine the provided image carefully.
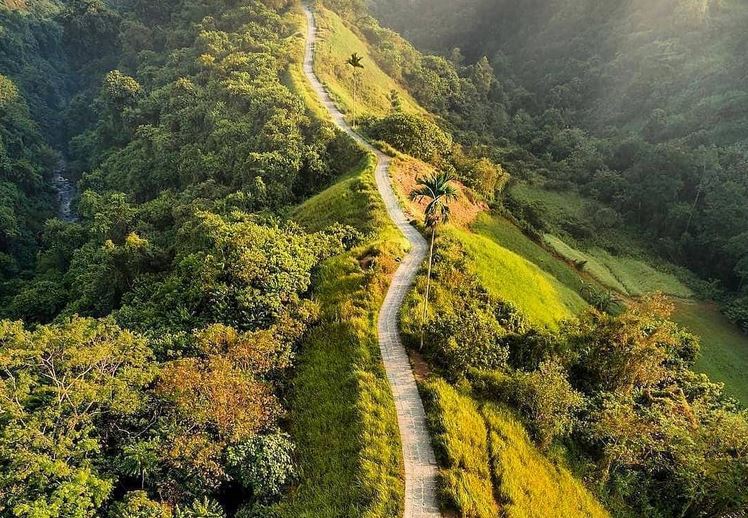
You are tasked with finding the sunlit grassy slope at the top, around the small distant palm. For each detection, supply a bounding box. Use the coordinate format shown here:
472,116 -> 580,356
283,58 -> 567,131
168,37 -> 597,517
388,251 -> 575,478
314,4 -> 426,116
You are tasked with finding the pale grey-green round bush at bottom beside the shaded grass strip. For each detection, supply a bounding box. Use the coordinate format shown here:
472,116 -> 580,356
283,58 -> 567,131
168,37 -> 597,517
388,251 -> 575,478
227,433 -> 296,501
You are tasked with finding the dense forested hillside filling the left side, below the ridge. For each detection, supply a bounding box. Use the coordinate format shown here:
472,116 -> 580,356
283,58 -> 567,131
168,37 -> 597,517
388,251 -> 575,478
0,0 -> 362,517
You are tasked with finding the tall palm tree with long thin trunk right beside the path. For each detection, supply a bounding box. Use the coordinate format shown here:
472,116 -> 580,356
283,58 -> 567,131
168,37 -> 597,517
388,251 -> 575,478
410,172 -> 457,349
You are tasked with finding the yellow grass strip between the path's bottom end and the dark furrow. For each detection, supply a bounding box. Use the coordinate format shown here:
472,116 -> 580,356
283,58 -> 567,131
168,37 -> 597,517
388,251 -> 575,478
422,379 -> 499,518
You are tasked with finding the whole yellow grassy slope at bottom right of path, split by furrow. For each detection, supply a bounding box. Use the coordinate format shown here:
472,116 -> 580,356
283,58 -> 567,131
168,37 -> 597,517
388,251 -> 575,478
423,379 -> 608,518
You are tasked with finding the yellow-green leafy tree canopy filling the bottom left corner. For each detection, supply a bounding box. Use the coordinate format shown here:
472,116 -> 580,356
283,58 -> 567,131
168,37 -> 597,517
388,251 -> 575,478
0,319 -> 156,517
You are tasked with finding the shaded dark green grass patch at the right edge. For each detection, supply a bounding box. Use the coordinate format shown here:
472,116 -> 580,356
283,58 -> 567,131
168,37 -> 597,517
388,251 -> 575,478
673,301 -> 748,407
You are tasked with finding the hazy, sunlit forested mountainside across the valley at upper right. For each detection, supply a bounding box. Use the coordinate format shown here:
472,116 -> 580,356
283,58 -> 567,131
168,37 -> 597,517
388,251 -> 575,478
375,0 -> 748,327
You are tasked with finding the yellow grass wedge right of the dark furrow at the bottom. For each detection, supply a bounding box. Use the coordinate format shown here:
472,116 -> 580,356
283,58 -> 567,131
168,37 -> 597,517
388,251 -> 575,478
481,403 -> 609,518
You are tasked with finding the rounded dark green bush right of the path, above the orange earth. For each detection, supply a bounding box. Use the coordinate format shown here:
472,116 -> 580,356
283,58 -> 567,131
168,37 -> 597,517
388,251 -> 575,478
368,112 -> 452,163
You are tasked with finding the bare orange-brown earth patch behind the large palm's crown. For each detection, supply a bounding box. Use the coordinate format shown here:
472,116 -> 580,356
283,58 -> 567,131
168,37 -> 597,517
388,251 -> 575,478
390,157 -> 488,227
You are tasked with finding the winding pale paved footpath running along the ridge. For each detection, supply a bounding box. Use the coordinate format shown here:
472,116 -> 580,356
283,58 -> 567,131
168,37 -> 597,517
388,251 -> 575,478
304,5 -> 441,518
